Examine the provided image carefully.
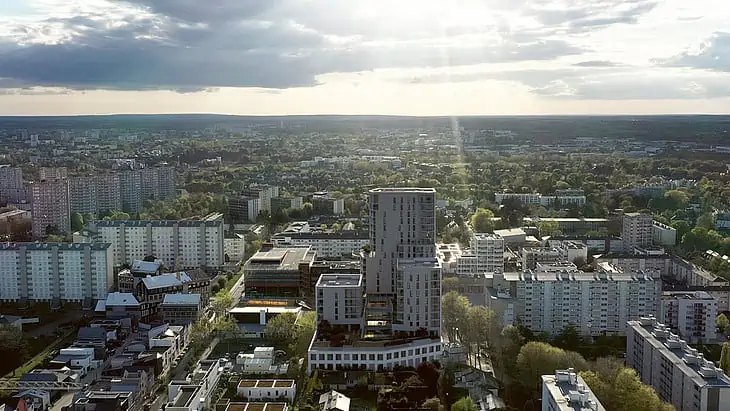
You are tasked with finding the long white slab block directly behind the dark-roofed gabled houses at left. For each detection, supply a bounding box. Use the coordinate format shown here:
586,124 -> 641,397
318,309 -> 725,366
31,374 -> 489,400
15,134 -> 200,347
87,214 -> 225,270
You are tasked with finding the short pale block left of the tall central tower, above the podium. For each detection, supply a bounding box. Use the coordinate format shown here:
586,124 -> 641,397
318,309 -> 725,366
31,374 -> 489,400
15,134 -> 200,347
315,274 -> 363,325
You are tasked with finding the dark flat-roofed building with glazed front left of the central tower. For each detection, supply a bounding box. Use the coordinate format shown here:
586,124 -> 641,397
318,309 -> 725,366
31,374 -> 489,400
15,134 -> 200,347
243,245 -> 315,298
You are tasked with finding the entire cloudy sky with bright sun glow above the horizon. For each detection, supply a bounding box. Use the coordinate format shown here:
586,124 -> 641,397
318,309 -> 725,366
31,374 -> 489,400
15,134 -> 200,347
0,0 -> 730,115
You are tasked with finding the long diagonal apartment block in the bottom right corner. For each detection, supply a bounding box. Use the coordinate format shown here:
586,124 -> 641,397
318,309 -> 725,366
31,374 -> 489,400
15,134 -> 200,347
626,317 -> 730,411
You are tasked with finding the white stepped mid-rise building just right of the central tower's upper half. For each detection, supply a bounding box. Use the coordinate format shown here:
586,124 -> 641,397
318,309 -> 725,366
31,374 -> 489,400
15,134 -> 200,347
456,233 -> 504,276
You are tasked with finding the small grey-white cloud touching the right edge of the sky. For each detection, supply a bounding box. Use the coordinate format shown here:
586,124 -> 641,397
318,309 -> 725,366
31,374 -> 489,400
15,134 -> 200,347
657,32 -> 730,72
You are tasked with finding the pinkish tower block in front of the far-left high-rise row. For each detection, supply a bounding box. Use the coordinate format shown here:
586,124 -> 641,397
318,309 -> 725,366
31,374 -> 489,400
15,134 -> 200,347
28,179 -> 71,238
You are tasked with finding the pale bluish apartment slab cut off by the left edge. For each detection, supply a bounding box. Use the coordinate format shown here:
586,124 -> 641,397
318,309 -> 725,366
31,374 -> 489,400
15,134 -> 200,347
0,243 -> 114,302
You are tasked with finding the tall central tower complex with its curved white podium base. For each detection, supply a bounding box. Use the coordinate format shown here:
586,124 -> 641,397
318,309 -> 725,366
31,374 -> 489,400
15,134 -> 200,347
308,188 -> 442,372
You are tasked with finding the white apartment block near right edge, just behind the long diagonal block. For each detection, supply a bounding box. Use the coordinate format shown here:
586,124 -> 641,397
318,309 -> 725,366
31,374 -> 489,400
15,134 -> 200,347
659,291 -> 718,344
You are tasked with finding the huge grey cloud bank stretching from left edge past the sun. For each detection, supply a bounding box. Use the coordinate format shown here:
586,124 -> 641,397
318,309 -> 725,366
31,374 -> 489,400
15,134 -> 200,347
0,0 -> 668,92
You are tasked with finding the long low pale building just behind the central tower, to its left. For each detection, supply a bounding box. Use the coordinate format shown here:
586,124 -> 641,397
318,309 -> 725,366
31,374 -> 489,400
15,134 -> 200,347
271,231 -> 370,260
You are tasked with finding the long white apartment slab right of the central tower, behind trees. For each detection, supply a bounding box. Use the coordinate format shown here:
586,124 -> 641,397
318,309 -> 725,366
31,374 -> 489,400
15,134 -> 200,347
486,263 -> 661,336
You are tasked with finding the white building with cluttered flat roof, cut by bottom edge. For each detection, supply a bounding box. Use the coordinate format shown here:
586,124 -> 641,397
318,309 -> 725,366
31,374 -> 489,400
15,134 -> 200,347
542,368 -> 606,411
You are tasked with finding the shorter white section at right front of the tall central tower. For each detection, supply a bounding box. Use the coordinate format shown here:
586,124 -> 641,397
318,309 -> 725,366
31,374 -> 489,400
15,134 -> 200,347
393,258 -> 441,335
